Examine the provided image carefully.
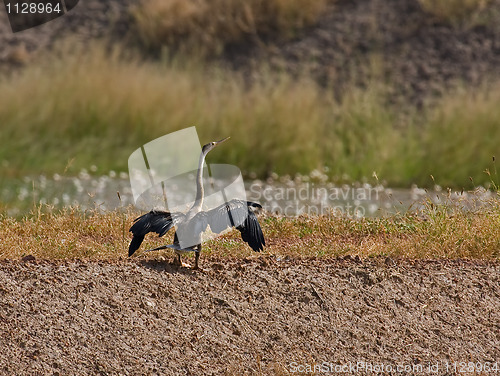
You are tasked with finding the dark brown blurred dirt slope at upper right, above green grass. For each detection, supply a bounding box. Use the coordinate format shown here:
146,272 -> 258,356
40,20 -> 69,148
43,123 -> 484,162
227,0 -> 500,106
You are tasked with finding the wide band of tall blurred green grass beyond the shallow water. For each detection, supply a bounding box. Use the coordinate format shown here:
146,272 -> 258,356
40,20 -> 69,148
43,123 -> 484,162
0,45 -> 500,187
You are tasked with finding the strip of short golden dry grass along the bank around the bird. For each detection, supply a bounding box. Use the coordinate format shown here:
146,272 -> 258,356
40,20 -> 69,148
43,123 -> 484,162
0,197 -> 500,260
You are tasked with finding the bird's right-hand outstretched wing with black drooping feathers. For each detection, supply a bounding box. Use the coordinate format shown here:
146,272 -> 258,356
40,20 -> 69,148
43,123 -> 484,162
206,200 -> 266,252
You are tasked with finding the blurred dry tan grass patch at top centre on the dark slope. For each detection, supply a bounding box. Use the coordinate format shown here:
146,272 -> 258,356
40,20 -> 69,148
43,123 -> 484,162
132,0 -> 329,54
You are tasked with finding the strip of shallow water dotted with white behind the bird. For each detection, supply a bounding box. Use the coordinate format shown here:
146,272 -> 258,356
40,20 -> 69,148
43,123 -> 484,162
0,171 -> 493,217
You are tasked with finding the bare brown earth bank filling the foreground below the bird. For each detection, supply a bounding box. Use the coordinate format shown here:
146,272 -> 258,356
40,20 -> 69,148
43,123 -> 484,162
0,256 -> 500,375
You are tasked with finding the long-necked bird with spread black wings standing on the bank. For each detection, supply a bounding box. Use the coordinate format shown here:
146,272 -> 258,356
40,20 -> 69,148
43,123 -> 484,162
128,137 -> 266,270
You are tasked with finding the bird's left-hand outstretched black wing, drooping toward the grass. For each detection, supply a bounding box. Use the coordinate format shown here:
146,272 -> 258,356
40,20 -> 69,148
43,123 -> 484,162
128,210 -> 174,256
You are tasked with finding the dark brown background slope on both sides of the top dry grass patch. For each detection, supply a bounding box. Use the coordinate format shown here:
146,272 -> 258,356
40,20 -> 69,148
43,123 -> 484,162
0,0 -> 500,106
